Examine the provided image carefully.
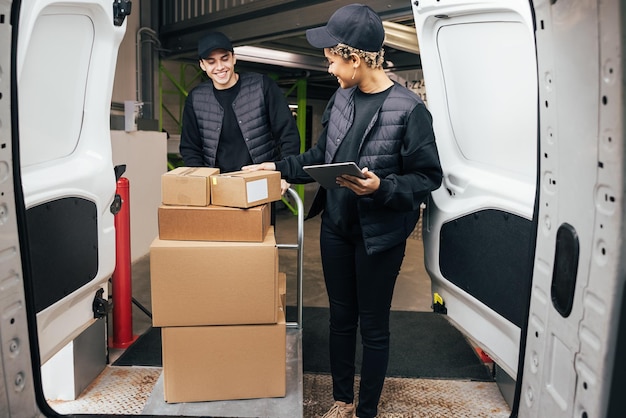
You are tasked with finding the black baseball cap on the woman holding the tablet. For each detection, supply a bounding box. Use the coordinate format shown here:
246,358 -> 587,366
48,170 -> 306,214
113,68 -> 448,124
306,3 -> 385,52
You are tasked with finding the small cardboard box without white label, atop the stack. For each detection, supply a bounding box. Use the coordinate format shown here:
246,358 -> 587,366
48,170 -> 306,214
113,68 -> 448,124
161,167 -> 220,206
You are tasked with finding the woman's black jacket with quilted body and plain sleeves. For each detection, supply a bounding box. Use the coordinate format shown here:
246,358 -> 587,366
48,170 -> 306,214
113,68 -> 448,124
277,83 -> 442,254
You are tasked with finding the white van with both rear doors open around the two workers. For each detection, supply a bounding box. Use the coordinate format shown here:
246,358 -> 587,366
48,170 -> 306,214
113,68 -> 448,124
0,0 -> 626,418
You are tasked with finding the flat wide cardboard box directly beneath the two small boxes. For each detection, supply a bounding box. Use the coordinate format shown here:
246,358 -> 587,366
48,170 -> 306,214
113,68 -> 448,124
159,204 -> 271,242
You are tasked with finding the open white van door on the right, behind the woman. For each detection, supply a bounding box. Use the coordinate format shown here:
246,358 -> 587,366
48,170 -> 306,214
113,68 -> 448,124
413,0 -> 538,384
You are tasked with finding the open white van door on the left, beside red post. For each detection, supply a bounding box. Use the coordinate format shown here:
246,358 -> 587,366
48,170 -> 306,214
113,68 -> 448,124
13,0 -> 125,378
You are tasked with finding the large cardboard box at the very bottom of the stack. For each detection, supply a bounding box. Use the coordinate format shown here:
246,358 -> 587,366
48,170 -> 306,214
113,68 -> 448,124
161,309 -> 287,403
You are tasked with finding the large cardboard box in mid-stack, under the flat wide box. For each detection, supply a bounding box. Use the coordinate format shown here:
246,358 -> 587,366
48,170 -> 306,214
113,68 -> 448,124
150,227 -> 278,327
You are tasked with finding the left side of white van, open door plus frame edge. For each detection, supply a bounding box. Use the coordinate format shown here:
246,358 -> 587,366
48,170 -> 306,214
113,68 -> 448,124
0,0 -> 130,417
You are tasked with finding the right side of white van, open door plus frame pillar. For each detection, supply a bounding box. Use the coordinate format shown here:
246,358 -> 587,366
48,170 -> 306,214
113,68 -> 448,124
412,0 -> 626,418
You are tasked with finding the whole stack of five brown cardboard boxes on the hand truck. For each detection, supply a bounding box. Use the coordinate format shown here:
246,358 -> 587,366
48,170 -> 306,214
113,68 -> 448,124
150,167 -> 286,403
